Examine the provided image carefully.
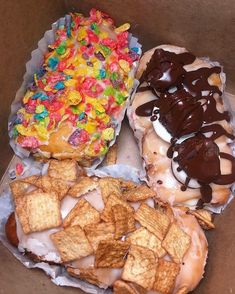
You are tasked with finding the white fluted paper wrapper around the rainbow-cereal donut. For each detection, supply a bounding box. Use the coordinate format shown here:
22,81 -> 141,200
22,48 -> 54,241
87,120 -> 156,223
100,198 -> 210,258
8,15 -> 142,169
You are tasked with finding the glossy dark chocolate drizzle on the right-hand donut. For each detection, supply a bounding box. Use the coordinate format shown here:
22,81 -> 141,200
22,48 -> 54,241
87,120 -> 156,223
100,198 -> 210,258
136,49 -> 235,203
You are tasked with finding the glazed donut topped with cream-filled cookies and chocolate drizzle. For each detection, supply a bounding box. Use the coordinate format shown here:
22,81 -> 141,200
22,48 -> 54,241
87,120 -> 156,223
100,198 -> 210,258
128,45 -> 235,206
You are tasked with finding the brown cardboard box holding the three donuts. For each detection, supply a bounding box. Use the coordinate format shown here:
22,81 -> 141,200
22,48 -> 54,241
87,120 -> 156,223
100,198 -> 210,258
0,0 -> 235,294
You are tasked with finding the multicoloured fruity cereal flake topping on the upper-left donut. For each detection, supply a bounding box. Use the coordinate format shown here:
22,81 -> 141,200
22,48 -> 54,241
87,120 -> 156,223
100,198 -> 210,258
13,9 -> 139,157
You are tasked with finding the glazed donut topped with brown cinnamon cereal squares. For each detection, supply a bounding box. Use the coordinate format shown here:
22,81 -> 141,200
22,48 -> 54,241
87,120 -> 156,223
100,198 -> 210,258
7,170 -> 208,293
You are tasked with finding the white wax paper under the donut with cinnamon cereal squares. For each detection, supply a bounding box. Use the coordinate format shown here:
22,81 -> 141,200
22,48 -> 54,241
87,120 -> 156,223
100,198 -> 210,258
0,157 -> 139,294
